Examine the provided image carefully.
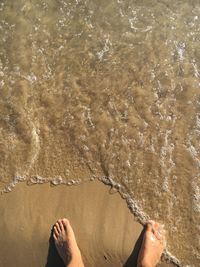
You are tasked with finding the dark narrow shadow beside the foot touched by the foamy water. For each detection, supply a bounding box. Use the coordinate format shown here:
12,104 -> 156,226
123,227 -> 146,267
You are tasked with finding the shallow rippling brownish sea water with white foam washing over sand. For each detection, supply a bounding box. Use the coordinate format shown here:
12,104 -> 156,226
0,0 -> 200,267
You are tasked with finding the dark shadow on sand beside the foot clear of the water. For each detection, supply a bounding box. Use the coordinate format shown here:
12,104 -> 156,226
45,229 -> 71,267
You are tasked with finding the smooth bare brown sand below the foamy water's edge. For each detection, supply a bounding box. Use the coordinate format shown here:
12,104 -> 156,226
0,181 -> 173,267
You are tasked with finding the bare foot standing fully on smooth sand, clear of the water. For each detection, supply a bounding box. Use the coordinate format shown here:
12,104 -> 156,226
53,219 -> 84,267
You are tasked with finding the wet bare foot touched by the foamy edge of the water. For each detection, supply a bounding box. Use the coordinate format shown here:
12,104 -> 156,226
137,221 -> 166,267
